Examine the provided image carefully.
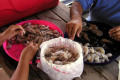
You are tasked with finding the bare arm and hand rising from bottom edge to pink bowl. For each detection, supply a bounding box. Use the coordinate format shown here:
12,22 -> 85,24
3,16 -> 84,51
11,42 -> 38,80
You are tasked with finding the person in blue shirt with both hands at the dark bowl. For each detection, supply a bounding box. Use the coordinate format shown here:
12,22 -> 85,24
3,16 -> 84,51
66,0 -> 120,41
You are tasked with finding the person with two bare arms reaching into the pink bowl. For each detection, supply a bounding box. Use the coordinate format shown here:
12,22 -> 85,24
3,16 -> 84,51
0,25 -> 38,80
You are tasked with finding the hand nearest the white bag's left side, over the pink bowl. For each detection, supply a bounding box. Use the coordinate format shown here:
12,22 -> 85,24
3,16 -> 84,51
20,42 -> 38,62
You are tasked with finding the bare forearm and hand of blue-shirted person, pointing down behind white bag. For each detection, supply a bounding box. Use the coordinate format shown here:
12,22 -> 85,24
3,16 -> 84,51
66,2 -> 83,40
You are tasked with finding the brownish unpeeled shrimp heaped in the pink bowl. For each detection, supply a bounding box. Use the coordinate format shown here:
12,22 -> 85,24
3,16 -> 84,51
7,23 -> 61,49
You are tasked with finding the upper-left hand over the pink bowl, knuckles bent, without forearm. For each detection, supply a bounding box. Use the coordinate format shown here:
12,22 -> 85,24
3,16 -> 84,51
2,25 -> 25,39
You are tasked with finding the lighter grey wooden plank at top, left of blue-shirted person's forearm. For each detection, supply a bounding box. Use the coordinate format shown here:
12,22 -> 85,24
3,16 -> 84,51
51,2 -> 70,22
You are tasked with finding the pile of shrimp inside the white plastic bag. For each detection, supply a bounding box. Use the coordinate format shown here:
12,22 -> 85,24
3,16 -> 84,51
45,46 -> 79,65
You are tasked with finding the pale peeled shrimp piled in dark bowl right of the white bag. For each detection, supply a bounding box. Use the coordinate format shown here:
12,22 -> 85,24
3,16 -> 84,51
83,43 -> 112,63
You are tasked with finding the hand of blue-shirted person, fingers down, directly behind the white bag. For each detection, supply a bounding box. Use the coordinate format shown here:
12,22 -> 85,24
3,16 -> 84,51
66,19 -> 82,40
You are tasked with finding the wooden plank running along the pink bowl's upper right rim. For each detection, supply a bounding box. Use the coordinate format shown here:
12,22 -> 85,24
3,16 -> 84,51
36,10 -> 66,33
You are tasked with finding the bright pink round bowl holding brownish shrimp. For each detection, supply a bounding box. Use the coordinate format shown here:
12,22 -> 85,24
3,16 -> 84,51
3,20 -> 64,63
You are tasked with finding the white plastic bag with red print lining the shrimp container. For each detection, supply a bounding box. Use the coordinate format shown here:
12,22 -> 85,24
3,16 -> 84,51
37,37 -> 84,80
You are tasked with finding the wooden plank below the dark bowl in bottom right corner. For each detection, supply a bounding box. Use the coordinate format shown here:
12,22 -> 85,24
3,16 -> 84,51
93,61 -> 118,80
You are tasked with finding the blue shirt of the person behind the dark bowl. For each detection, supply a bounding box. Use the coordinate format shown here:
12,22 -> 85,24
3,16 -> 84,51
75,0 -> 120,26
